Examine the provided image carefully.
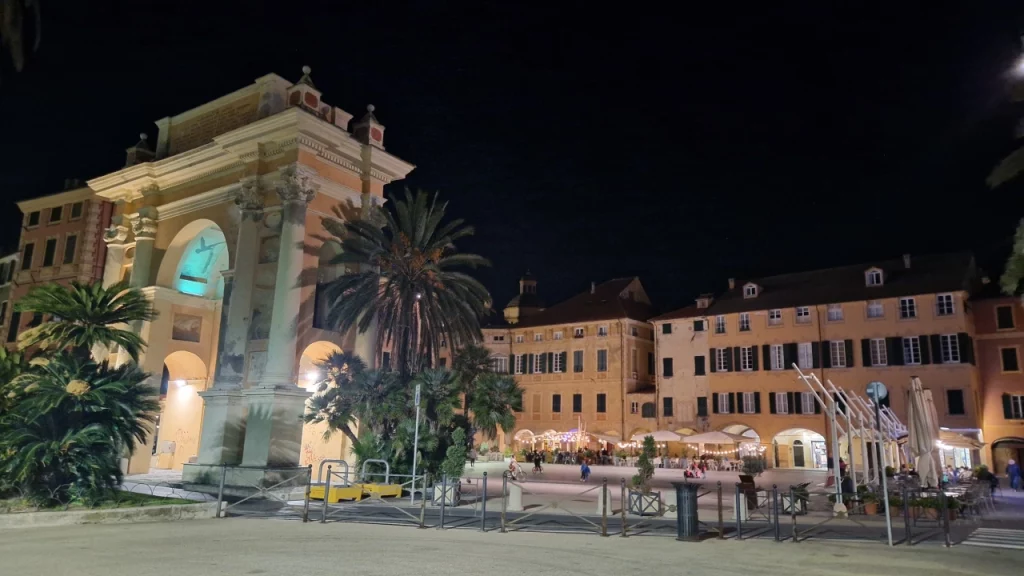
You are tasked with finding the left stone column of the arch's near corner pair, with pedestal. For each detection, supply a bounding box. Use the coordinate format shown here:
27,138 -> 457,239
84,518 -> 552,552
186,176 -> 264,466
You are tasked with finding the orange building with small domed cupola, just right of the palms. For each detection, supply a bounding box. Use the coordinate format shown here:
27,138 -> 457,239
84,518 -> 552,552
483,277 -> 657,449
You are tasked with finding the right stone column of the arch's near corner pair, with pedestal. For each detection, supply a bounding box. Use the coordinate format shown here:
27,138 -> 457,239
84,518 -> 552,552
242,165 -> 315,466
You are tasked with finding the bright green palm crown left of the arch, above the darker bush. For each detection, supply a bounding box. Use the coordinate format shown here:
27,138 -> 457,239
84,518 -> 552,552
14,282 -> 157,362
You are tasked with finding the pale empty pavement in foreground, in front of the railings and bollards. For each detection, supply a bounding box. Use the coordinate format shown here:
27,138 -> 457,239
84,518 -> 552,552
0,512 -> 1024,576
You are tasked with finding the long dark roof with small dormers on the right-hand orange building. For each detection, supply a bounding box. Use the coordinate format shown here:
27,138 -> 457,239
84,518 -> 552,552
654,252 -> 975,321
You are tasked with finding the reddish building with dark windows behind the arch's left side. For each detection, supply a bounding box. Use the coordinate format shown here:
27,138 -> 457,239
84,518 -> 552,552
9,180 -> 114,347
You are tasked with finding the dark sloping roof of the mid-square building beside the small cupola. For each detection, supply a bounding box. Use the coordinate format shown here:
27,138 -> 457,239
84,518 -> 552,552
495,278 -> 654,328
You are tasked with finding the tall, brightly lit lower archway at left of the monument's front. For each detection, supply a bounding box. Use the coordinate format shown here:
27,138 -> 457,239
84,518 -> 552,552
151,351 -> 208,470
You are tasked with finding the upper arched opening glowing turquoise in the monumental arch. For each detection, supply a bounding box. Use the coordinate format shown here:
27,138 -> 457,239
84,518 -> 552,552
157,219 -> 229,300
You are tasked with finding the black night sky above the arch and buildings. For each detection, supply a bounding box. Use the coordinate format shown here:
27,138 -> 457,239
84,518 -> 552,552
0,0 -> 1024,310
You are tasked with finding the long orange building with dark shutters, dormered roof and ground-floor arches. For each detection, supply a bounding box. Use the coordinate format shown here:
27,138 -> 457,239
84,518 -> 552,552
655,252 -> 982,468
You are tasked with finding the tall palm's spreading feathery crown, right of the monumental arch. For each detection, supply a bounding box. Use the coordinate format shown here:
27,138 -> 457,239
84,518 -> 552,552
325,190 -> 490,379
